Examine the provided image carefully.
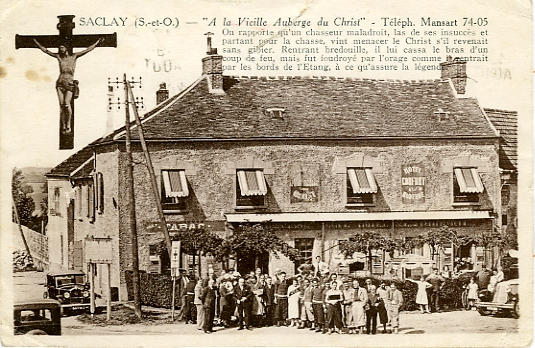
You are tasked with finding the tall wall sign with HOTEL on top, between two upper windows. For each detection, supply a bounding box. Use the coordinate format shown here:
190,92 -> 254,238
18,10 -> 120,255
401,163 -> 425,204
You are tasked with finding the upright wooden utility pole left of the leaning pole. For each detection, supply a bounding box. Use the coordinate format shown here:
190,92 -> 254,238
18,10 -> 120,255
123,74 -> 141,318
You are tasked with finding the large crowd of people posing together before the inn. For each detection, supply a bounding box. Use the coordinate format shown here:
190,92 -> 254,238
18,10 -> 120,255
174,260 -> 403,334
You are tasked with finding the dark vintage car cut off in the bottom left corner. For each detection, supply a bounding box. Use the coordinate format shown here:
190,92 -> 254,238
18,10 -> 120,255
13,299 -> 61,335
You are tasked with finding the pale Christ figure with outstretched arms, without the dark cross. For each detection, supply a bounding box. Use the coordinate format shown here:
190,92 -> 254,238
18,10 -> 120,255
33,38 -> 103,133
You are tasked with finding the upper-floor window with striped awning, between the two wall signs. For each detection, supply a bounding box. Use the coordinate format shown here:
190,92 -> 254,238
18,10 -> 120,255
346,168 -> 377,205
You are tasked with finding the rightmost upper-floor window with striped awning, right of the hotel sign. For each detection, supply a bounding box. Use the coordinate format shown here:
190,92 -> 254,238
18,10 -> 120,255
453,168 -> 484,203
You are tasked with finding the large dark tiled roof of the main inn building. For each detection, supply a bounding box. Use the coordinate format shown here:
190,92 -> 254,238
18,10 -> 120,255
107,77 -> 497,140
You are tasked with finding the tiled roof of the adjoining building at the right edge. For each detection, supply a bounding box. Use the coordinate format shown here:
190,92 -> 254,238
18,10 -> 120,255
485,109 -> 518,170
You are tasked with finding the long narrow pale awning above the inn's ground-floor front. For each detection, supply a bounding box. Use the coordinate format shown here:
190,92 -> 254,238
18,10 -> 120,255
225,210 -> 491,222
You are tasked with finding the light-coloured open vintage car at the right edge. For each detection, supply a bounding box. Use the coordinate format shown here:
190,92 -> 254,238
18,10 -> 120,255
475,279 -> 520,318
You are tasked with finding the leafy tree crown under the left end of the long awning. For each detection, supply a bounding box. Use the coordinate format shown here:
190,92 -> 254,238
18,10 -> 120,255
221,222 -> 301,267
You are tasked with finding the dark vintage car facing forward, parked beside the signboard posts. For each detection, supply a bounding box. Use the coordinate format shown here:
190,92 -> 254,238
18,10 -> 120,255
43,270 -> 91,315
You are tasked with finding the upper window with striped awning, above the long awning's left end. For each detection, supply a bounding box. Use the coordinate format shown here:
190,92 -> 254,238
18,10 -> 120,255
236,169 -> 267,207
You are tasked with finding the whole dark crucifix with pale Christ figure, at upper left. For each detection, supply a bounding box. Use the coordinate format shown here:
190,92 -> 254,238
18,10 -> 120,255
15,15 -> 117,150
